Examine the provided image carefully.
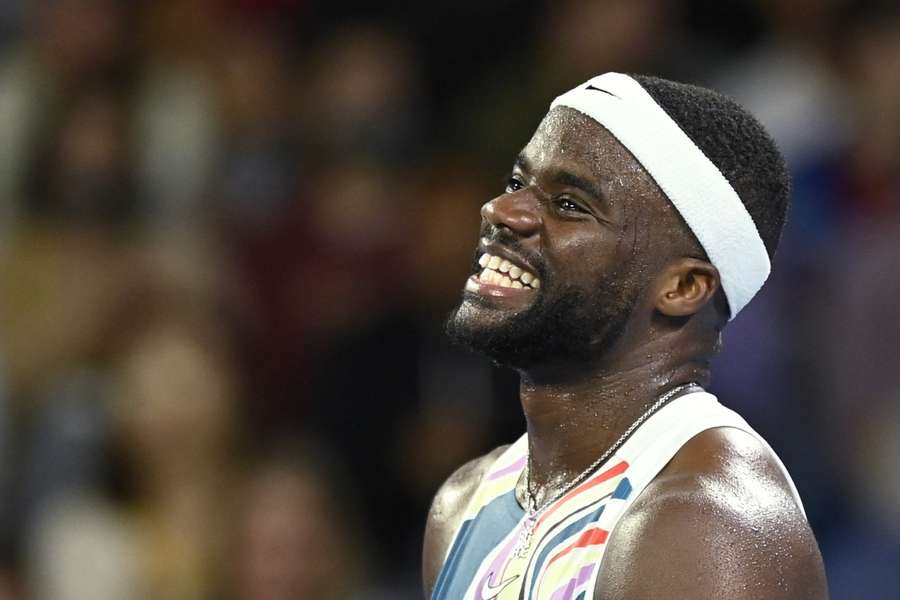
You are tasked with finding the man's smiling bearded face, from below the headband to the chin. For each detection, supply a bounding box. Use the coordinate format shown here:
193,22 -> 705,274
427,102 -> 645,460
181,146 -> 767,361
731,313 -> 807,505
447,108 -> 667,370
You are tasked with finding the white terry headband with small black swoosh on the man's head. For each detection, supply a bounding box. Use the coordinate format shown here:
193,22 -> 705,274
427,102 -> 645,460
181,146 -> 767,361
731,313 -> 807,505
550,73 -> 771,319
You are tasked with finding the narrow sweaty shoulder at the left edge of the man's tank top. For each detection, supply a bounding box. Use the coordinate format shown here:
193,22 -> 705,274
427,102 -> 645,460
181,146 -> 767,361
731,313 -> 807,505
422,445 -> 509,598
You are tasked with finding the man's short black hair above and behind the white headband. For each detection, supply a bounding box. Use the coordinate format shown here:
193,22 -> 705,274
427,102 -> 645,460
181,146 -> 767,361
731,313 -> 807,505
631,75 -> 790,258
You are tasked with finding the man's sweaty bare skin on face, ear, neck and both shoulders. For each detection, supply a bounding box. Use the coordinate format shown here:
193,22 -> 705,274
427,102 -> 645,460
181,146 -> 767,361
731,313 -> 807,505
423,108 -> 828,600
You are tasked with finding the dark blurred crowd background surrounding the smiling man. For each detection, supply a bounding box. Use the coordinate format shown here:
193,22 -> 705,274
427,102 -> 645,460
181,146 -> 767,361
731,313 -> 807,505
0,0 -> 900,600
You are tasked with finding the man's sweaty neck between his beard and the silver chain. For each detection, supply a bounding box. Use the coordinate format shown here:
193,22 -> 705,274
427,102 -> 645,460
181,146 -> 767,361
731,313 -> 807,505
520,326 -> 709,505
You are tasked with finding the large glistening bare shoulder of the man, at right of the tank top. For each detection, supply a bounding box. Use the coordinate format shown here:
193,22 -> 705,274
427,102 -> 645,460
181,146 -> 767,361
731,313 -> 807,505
594,428 -> 828,600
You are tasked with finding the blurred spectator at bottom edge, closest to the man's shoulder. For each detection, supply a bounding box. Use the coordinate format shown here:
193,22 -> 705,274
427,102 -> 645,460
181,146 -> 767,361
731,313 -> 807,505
226,445 -> 367,600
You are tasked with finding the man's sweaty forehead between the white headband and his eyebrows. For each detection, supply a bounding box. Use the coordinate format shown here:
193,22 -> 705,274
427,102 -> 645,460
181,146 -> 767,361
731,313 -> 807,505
522,107 -> 661,198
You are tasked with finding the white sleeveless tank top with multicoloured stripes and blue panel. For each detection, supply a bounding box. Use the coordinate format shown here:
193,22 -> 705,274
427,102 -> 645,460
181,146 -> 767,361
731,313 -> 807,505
431,391 -> 803,600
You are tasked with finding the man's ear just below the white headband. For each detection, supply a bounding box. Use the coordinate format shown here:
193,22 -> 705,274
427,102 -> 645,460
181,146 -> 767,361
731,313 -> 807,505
655,258 -> 719,317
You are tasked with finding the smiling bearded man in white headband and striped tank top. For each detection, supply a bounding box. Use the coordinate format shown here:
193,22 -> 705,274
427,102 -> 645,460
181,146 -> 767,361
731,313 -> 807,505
423,73 -> 827,600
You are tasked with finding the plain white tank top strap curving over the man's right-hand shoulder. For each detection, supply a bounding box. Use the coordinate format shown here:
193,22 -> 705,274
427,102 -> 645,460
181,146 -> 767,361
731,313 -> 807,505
616,391 -> 806,516
